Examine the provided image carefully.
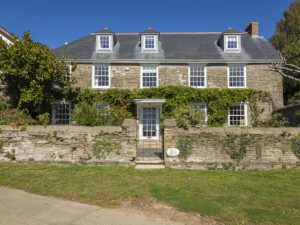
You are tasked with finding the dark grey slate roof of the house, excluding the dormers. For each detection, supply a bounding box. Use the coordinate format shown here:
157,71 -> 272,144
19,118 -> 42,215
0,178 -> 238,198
54,29 -> 280,63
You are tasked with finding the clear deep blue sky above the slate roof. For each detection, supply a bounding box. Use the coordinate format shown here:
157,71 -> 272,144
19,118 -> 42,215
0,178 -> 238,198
0,0 -> 293,48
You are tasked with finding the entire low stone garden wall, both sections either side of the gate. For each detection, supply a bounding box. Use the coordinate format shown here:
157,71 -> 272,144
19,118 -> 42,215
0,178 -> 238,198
0,119 -> 300,169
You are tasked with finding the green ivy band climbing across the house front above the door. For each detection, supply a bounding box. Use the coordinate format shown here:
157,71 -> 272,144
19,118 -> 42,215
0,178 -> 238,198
75,86 -> 272,127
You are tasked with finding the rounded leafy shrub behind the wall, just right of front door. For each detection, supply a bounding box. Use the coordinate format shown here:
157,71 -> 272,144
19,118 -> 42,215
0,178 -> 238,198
174,105 -> 204,129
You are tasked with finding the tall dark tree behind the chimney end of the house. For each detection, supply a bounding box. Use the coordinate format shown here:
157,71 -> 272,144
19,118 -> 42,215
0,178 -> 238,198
270,1 -> 300,102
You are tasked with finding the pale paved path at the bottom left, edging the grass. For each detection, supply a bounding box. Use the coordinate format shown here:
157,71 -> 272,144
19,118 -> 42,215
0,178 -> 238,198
0,186 -> 182,225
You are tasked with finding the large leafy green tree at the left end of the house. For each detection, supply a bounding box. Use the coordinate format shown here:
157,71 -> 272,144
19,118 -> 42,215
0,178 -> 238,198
0,32 -> 72,118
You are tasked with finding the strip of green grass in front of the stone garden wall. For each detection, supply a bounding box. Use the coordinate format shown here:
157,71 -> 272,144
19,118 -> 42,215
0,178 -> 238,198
0,163 -> 300,225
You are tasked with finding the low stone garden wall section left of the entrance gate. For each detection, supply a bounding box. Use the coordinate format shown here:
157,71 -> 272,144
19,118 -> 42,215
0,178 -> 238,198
0,119 -> 136,164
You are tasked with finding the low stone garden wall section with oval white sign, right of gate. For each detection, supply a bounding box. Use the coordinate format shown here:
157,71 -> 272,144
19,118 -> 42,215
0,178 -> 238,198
164,123 -> 300,169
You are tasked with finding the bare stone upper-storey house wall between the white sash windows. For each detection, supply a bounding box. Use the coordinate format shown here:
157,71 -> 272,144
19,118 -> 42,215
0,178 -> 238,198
72,64 -> 283,108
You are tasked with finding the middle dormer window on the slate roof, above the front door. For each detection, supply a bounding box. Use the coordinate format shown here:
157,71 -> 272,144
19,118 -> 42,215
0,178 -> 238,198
141,28 -> 159,52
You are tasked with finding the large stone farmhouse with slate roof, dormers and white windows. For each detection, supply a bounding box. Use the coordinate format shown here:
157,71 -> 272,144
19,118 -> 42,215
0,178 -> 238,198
52,22 -> 283,140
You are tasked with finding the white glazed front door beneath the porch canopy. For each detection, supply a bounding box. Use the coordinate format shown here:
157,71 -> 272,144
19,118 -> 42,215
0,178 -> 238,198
140,107 -> 159,139
